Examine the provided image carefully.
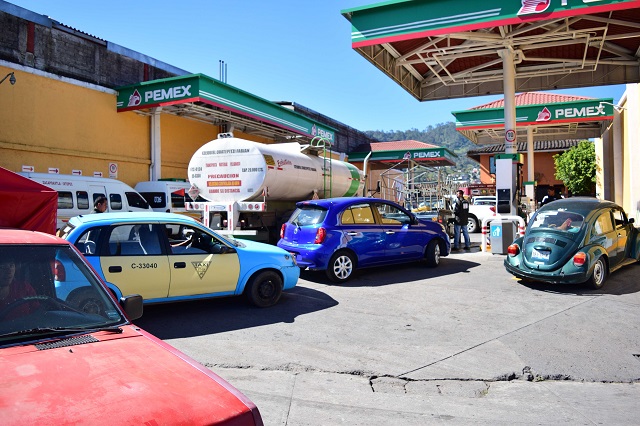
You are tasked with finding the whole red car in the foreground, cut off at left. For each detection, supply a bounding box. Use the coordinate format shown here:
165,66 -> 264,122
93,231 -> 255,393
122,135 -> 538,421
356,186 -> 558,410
0,229 -> 262,426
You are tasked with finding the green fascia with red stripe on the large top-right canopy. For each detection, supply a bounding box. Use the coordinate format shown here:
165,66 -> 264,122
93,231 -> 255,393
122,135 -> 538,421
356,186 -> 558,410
341,0 -> 640,48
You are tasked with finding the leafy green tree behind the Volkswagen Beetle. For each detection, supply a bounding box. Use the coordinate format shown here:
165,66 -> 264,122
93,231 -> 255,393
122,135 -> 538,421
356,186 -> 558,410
553,140 -> 596,195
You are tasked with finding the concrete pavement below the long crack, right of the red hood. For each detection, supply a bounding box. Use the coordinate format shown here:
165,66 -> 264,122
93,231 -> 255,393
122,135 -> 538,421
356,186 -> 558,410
225,369 -> 640,426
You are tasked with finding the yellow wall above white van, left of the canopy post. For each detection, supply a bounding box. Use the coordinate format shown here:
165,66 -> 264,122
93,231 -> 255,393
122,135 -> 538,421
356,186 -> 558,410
0,67 -> 150,185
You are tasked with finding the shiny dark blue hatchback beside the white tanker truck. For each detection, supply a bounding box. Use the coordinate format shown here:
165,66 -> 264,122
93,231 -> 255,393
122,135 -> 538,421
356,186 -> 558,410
278,197 -> 451,283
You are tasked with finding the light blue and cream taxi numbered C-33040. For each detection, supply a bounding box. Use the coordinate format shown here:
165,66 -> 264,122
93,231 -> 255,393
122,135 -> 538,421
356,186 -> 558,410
57,212 -> 300,311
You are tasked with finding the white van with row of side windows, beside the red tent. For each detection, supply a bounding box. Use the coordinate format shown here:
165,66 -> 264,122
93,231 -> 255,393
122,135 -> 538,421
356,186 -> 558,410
18,172 -> 151,229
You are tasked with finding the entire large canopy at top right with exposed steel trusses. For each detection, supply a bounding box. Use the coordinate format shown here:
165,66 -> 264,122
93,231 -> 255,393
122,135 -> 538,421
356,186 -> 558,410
342,0 -> 640,101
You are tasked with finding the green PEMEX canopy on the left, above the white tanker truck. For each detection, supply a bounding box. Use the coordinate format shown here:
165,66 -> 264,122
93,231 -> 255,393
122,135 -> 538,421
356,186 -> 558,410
117,74 -> 335,143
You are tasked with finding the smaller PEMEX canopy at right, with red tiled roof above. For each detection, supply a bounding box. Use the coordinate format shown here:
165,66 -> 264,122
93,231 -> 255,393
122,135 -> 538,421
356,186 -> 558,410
452,92 -> 613,145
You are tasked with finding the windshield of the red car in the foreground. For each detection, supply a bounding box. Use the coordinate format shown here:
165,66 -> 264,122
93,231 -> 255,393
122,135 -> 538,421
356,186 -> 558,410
0,244 -> 127,345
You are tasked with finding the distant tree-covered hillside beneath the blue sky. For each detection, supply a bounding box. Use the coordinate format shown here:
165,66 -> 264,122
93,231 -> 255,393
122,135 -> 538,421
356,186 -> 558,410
365,122 -> 478,180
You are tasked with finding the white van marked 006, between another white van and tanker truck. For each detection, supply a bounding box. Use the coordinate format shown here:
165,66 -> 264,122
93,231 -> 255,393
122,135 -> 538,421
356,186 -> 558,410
135,179 -> 206,219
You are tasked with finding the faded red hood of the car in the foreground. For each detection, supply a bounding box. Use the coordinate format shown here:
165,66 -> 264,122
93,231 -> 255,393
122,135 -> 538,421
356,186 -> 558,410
0,326 -> 262,425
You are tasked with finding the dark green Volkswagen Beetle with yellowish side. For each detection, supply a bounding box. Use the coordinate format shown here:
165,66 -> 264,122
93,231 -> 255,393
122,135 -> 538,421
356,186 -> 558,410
504,197 -> 640,289
